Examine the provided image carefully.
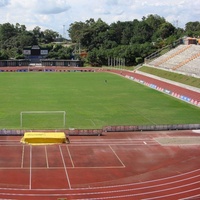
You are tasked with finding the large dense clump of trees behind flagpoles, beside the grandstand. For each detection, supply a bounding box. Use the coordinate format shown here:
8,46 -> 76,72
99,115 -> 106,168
69,15 -> 186,65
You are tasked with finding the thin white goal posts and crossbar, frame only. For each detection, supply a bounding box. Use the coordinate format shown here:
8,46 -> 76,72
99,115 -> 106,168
20,111 -> 66,128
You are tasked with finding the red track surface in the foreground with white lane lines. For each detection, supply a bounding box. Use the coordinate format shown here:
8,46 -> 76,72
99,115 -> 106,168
0,131 -> 200,200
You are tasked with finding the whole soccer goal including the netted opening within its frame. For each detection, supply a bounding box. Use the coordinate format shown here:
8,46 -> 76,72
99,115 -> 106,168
20,111 -> 66,129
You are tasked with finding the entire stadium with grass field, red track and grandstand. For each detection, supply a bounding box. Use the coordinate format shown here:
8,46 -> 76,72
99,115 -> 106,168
0,41 -> 200,200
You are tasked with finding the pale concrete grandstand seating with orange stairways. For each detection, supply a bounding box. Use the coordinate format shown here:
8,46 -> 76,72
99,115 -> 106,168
148,44 -> 200,77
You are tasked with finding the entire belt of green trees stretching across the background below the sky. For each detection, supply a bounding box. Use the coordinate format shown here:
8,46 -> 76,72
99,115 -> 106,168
0,15 -> 195,65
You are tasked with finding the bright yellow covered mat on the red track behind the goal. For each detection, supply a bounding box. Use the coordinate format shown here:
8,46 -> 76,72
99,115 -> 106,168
21,132 -> 66,145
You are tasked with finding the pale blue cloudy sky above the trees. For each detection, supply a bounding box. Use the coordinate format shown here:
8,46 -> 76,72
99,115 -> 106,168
0,0 -> 200,37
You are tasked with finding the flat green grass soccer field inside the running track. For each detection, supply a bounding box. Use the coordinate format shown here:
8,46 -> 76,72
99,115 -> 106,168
0,72 -> 200,129
